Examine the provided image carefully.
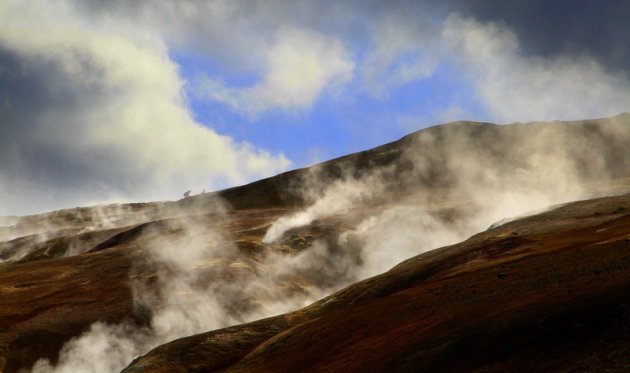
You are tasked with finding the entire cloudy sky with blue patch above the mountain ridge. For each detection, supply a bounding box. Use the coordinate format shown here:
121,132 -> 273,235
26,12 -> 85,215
0,0 -> 630,215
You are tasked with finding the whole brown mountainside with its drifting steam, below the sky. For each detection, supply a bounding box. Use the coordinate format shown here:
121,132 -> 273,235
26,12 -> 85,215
0,114 -> 630,372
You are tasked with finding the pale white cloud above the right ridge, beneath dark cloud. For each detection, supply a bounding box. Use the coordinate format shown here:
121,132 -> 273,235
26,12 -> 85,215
442,15 -> 630,122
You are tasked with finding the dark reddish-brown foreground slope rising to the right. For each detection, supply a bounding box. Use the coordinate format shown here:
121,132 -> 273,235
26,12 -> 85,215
124,195 -> 630,373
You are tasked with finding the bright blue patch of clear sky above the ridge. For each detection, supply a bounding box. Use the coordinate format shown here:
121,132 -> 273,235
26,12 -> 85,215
171,48 -> 487,167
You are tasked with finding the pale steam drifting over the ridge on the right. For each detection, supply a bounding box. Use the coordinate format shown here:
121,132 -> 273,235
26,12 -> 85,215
263,115 -> 630,280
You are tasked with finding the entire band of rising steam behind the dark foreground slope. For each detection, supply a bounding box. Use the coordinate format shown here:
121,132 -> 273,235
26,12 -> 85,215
23,117 -> 630,373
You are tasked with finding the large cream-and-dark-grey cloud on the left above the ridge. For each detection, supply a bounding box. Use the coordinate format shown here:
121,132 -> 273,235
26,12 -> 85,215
0,1 -> 289,214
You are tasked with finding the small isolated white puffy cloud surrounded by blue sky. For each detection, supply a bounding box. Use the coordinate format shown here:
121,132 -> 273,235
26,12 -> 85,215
201,27 -> 354,115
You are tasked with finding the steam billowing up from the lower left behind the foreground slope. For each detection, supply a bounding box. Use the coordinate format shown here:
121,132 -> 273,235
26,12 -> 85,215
28,197 -> 349,373
